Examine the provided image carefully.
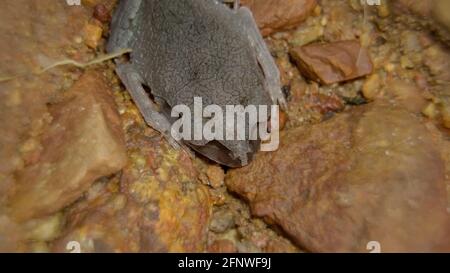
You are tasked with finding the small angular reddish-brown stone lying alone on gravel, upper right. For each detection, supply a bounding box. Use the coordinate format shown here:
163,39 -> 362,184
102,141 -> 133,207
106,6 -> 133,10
290,40 -> 373,84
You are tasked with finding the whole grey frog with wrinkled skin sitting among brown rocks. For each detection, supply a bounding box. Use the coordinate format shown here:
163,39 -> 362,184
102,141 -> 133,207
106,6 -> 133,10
108,0 -> 285,167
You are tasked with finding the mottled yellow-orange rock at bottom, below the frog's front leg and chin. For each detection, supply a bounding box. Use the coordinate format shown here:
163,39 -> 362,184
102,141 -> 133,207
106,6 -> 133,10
53,110 -> 212,252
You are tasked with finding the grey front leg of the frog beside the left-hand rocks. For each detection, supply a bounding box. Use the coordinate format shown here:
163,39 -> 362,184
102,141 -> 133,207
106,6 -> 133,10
116,64 -> 182,149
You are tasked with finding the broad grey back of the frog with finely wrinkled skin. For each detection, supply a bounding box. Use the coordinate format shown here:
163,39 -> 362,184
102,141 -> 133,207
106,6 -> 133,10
112,0 -> 270,106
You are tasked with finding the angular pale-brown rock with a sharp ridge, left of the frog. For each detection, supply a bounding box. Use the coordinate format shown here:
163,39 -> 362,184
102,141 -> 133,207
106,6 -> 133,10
9,72 -> 126,220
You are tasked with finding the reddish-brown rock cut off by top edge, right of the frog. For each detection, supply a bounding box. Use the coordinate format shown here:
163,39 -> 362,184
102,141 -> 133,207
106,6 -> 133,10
241,0 -> 317,36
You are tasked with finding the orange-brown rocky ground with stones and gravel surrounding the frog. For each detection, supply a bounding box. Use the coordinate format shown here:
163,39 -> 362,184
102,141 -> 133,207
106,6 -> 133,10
0,0 -> 450,252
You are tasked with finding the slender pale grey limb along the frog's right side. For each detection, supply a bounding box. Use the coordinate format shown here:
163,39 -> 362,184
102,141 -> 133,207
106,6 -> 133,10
237,7 -> 287,109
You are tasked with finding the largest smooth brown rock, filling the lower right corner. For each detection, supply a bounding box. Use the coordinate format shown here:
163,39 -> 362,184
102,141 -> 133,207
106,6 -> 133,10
226,102 -> 450,252
